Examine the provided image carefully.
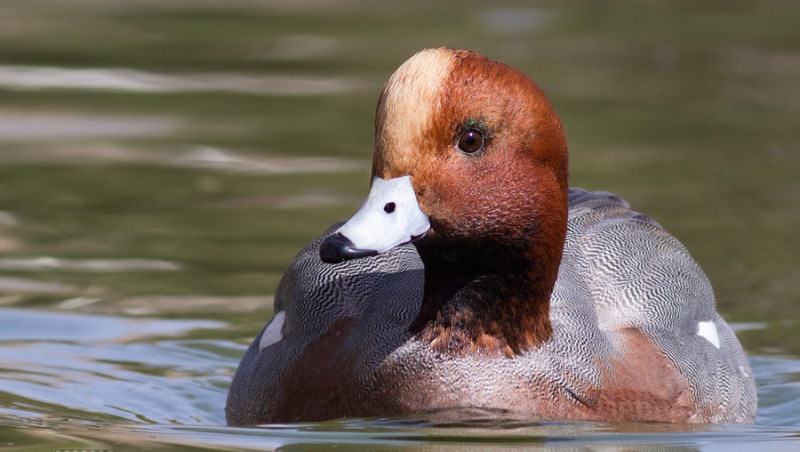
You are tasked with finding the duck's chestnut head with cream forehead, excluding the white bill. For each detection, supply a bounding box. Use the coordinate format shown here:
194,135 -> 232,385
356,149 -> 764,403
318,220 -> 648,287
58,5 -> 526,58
373,49 -> 567,264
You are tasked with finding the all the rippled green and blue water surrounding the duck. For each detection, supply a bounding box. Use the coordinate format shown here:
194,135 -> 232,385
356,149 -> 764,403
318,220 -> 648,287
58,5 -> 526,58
0,0 -> 800,450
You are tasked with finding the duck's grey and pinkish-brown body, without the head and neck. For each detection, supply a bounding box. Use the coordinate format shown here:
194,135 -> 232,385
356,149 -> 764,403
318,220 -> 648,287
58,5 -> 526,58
226,189 -> 755,425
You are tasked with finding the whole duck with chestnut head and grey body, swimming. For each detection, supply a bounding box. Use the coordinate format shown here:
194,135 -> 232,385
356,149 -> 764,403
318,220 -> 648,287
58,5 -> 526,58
225,48 -> 757,426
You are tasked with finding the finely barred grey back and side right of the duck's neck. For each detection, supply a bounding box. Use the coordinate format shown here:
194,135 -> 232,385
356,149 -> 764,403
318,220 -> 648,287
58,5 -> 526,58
551,189 -> 756,423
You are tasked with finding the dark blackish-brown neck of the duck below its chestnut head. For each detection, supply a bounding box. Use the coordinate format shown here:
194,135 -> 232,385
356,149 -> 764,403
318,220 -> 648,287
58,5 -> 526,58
410,236 -> 563,357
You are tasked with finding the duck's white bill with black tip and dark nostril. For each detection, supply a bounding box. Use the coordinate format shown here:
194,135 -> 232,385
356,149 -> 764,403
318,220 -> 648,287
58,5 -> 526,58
319,176 -> 430,263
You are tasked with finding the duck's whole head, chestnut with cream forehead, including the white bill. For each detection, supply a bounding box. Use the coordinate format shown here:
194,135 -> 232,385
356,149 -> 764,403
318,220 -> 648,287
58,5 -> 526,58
321,48 -> 568,280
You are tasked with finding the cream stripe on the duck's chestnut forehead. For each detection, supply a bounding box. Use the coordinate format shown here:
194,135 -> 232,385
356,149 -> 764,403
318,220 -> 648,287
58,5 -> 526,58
375,49 -> 455,168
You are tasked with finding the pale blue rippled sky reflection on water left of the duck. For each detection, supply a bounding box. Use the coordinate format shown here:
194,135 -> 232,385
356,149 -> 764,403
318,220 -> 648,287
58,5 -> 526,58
0,309 -> 231,424
